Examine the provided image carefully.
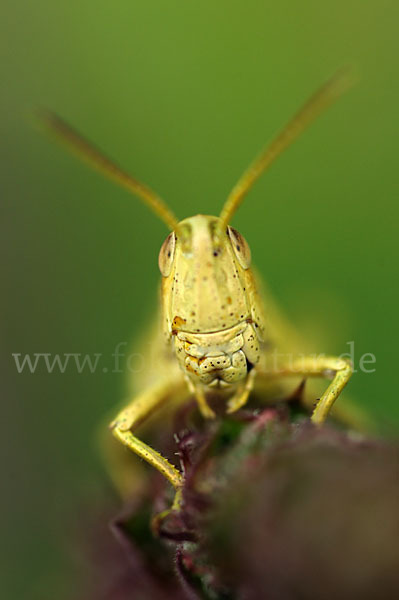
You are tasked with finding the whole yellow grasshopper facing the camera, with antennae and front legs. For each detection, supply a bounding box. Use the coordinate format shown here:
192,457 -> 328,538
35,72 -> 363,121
41,71 -> 360,500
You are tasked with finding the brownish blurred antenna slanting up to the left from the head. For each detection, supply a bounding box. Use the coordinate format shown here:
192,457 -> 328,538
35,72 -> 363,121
36,109 -> 178,230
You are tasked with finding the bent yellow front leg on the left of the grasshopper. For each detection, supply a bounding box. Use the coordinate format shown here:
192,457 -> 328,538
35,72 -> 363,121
110,379 -> 184,489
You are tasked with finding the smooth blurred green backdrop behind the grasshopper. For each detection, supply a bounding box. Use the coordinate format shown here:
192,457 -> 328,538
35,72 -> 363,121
0,0 -> 399,600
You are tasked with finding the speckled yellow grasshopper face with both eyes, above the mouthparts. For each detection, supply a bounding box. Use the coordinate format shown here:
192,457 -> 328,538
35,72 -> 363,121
159,215 -> 251,334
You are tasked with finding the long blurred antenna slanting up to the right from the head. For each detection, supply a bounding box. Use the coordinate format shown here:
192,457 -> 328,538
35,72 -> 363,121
218,67 -> 355,234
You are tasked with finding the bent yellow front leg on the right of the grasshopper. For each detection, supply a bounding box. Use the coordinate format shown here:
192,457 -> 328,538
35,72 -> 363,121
259,356 -> 353,425
